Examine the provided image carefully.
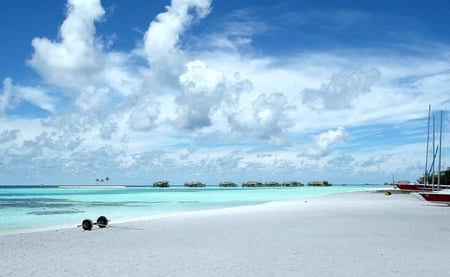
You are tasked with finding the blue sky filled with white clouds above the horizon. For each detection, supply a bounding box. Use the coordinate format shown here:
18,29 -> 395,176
0,0 -> 450,185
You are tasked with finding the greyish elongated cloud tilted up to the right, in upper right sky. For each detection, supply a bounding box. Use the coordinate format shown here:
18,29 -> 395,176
302,68 -> 381,110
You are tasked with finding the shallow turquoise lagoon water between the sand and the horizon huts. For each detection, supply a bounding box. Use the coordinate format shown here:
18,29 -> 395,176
0,185 -> 380,233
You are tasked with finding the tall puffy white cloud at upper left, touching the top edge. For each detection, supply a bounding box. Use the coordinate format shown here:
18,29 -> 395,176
28,0 -> 105,87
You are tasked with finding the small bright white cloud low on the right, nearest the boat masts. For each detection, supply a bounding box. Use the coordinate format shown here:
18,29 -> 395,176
307,127 -> 346,157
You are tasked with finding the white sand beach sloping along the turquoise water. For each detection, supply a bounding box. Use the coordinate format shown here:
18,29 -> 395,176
0,192 -> 450,277
